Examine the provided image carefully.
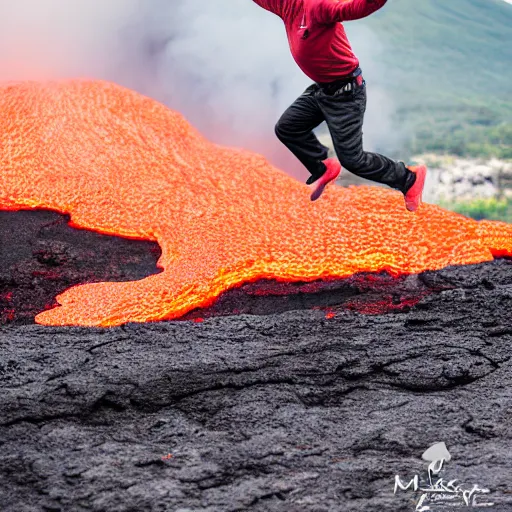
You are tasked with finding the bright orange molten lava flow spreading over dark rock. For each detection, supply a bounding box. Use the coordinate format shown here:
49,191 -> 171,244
0,81 -> 512,327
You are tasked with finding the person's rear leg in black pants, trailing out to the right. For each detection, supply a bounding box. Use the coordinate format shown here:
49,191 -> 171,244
317,85 -> 416,194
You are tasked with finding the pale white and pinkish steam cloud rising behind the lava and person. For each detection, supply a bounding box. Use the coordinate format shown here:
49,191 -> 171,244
0,0 -> 401,179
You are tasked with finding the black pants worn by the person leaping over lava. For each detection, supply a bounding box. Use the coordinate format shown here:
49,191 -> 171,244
276,75 -> 415,193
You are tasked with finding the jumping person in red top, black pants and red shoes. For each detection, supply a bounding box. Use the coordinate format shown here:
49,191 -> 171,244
253,0 -> 427,211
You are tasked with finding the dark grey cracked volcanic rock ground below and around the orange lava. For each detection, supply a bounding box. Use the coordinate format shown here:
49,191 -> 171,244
0,212 -> 512,512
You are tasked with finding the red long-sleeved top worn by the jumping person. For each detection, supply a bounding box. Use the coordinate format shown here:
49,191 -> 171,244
253,0 -> 387,83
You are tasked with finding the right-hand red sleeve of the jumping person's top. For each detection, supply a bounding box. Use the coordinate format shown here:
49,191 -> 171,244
309,0 -> 387,24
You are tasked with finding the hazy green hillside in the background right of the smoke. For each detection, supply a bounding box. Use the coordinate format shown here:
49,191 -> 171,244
347,0 -> 512,158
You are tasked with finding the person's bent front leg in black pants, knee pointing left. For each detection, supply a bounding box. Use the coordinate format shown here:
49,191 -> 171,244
275,84 -> 329,183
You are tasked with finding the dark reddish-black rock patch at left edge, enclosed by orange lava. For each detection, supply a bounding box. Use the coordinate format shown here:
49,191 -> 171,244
0,210 -> 161,325
